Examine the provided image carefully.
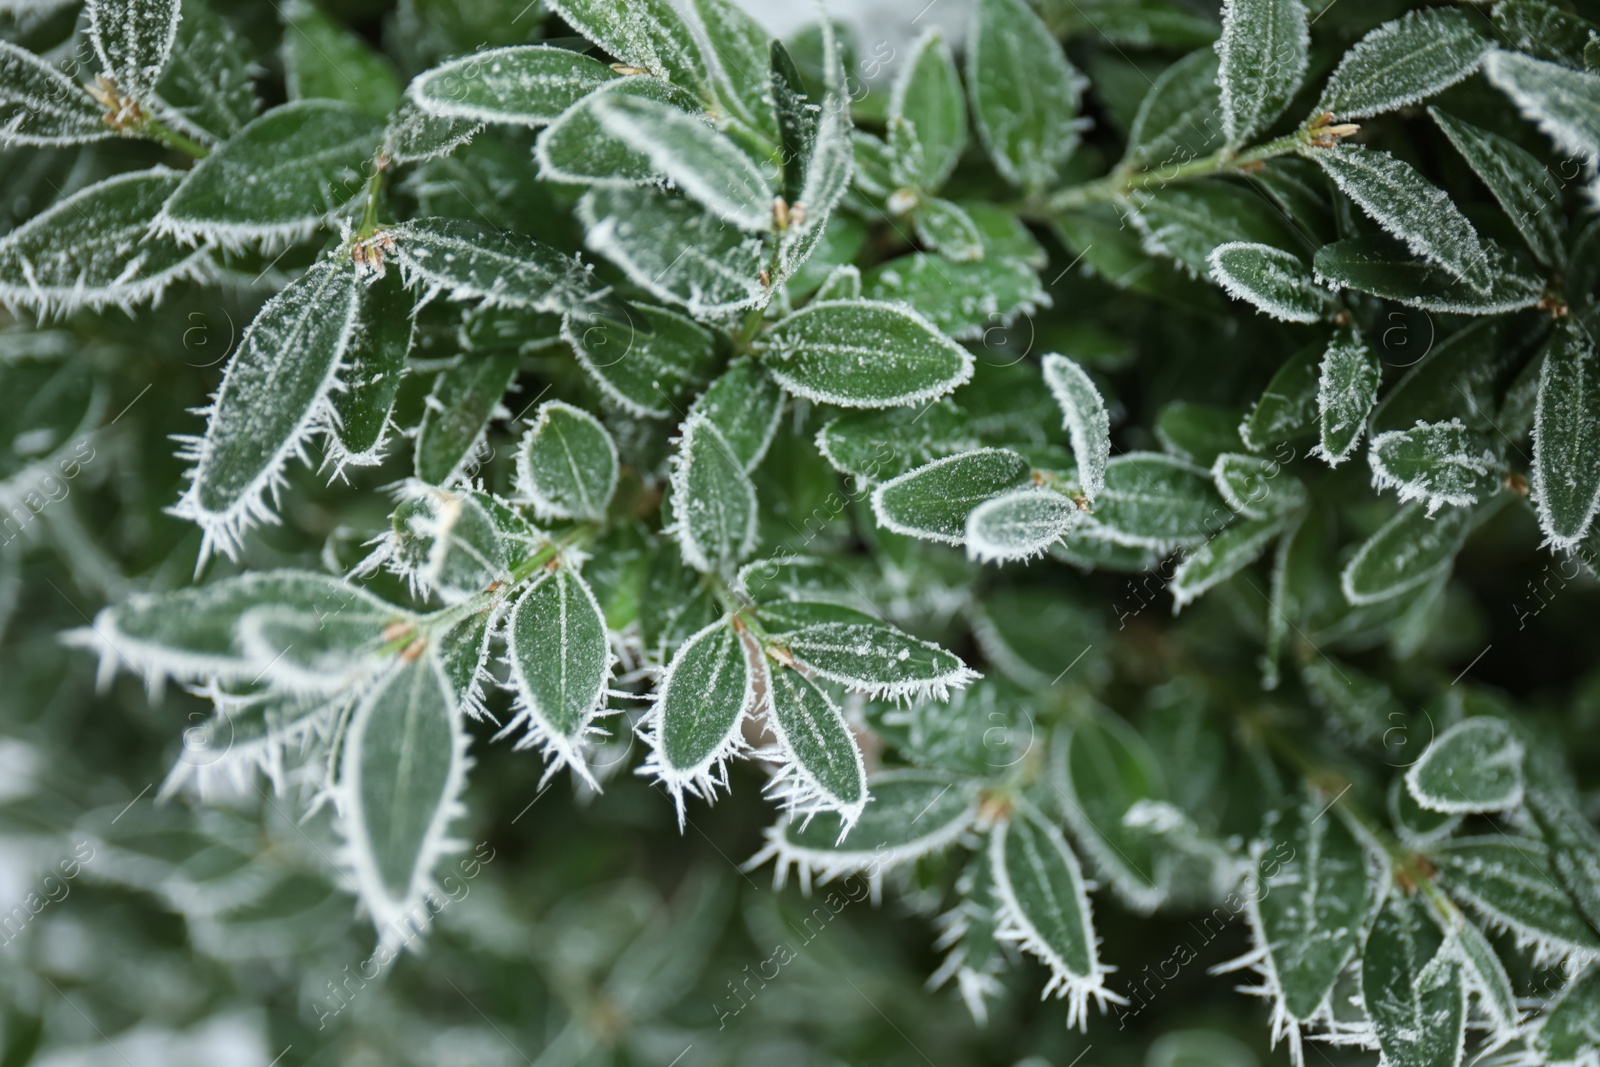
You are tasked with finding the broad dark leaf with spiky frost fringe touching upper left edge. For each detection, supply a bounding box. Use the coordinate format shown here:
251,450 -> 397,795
0,166 -> 210,314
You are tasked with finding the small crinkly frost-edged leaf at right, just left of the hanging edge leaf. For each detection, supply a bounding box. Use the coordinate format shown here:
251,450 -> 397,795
1366,419 -> 1502,515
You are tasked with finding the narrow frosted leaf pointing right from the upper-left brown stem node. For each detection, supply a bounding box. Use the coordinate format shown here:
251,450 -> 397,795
387,218 -> 600,314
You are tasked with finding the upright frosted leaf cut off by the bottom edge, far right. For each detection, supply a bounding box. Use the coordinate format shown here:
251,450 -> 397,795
1362,893 -> 1467,1067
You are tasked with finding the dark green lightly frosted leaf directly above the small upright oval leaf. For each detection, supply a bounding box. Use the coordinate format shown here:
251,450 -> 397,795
562,304 -> 717,419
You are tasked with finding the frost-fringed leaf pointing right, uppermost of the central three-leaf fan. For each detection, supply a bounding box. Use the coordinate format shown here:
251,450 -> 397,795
762,600 -> 978,701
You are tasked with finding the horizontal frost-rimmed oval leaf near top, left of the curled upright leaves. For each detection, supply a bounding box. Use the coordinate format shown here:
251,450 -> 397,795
406,45 -> 616,126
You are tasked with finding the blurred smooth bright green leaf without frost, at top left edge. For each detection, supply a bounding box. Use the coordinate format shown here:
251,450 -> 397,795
280,0 -> 400,118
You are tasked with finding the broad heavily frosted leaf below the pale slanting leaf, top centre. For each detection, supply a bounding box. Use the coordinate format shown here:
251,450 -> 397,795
582,182 -> 771,318
